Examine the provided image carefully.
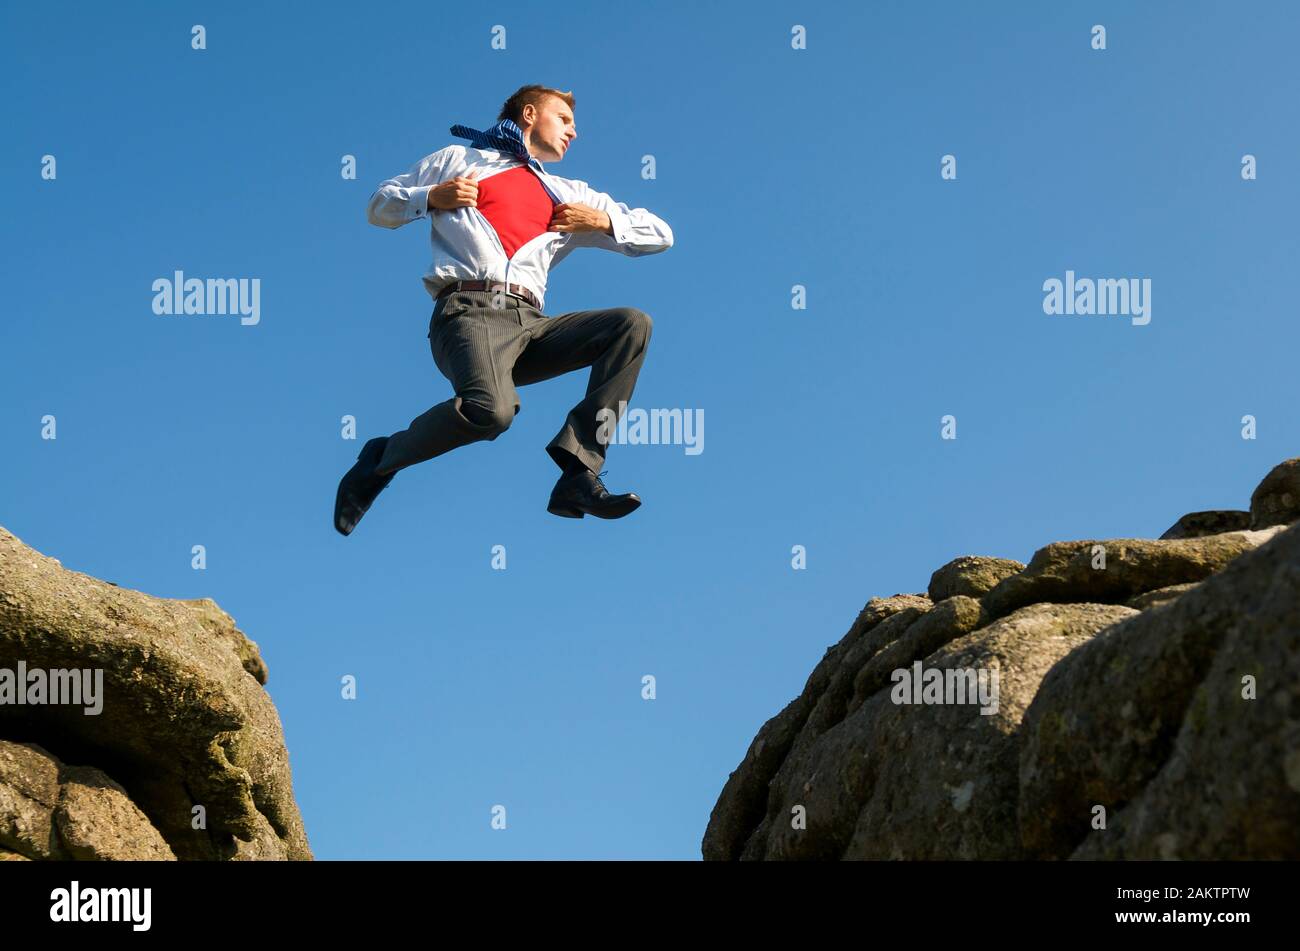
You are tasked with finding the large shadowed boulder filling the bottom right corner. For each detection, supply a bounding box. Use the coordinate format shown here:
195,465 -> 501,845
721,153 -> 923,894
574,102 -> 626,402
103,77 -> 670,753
1021,526 -> 1300,859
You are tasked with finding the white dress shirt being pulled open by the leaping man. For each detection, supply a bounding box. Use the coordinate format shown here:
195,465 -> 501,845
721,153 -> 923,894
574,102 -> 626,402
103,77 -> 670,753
367,146 -> 672,305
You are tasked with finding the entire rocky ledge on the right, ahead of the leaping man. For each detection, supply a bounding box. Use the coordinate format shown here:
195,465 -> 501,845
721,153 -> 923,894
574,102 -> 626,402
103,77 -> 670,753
702,459 -> 1300,860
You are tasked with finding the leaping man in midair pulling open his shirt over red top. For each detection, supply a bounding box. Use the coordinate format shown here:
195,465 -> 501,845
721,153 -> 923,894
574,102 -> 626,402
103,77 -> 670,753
334,86 -> 672,535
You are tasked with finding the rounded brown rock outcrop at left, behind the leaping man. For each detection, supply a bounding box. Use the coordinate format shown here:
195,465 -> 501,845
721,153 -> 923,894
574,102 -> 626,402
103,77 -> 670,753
0,529 -> 312,860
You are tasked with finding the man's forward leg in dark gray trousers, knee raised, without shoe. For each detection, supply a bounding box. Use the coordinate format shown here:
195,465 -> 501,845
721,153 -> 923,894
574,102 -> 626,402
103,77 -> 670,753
514,307 -> 654,474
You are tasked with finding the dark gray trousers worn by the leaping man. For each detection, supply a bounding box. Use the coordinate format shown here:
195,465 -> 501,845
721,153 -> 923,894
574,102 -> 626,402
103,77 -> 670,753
376,285 -> 653,474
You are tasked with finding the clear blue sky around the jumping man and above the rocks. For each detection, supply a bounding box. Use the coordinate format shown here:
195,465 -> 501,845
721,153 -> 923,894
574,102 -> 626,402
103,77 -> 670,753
0,3 -> 1300,859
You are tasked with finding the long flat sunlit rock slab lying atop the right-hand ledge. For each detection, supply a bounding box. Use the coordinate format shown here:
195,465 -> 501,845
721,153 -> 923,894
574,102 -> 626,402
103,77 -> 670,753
983,529 -> 1278,618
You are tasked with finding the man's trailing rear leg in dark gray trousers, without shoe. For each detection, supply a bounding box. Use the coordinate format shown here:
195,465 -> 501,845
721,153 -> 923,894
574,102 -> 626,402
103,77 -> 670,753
374,297 -> 528,476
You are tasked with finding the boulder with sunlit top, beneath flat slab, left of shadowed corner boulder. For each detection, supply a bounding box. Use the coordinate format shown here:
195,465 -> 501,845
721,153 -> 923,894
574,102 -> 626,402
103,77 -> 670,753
742,604 -> 1134,860
